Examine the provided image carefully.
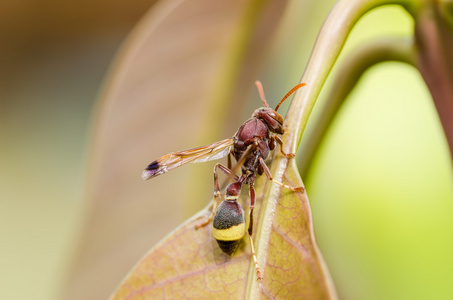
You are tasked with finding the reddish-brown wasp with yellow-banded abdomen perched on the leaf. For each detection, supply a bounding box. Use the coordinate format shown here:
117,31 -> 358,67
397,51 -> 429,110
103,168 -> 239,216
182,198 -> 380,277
142,81 -> 305,279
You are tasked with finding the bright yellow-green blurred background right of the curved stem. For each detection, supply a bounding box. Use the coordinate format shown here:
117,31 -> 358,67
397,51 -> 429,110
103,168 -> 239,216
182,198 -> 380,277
305,6 -> 453,299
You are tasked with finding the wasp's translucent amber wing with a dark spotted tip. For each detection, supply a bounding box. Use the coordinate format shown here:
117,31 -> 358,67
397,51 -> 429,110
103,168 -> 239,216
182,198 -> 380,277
142,139 -> 234,180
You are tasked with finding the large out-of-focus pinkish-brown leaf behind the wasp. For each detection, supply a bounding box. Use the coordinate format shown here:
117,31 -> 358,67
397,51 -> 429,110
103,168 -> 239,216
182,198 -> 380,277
62,0 -> 286,299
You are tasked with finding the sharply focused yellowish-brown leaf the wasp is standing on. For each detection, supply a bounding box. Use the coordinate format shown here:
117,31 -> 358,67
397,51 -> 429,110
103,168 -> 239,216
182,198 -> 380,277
113,158 -> 336,299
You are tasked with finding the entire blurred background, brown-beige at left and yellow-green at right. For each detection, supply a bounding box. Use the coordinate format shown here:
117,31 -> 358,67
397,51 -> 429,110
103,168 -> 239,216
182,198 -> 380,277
0,0 -> 453,299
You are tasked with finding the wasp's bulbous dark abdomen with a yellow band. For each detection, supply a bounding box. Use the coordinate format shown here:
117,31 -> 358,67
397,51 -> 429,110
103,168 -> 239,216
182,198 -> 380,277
212,200 -> 245,255
